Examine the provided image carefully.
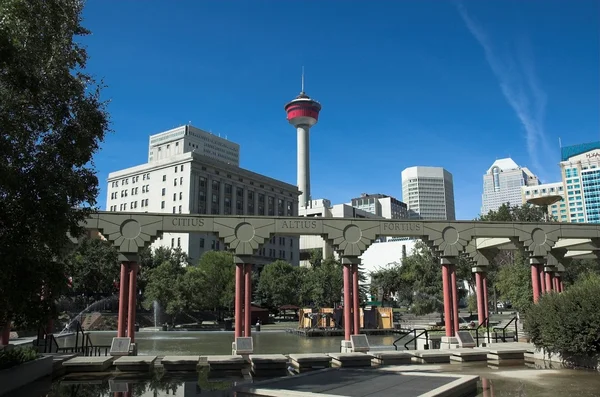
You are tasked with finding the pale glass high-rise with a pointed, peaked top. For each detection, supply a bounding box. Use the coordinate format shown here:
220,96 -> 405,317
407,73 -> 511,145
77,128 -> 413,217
481,158 -> 540,215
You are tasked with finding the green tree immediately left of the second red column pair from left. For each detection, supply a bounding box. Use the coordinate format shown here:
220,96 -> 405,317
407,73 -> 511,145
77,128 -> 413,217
197,251 -> 235,317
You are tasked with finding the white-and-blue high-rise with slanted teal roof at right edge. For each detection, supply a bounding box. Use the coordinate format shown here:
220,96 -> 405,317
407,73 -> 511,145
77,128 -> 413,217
560,141 -> 600,223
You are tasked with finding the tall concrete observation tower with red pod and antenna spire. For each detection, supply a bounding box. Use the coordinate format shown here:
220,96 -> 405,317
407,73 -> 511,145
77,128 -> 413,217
285,83 -> 321,207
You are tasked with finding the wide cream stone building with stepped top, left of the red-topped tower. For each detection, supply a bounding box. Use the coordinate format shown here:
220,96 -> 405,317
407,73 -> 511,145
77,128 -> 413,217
106,126 -> 299,265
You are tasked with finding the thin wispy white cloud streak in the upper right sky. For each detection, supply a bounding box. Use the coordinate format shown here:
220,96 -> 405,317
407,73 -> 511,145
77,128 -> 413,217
458,4 -> 549,173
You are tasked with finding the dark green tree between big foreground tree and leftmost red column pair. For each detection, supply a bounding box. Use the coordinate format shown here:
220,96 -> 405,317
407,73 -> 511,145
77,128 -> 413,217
65,238 -> 120,297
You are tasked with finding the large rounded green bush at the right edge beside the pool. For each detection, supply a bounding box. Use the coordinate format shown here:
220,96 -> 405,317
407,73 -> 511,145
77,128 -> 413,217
524,275 -> 600,366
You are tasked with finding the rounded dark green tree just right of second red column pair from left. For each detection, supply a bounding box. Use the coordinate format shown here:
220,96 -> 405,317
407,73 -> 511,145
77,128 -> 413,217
257,260 -> 298,313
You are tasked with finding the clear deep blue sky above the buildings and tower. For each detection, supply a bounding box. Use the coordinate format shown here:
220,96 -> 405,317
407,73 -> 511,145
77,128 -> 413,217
83,0 -> 600,219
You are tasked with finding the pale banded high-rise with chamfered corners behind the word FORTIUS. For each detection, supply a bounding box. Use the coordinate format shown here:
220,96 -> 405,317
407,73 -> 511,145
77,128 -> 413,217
402,166 -> 456,220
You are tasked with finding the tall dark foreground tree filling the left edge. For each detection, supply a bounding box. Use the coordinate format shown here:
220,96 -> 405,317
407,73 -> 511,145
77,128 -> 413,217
0,0 -> 109,323
